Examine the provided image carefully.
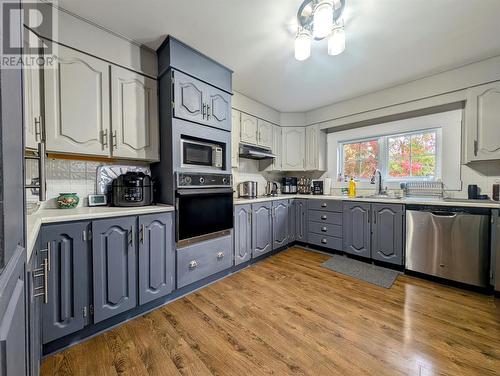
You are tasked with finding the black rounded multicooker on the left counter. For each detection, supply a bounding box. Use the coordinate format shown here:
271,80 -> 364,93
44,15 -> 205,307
111,171 -> 153,206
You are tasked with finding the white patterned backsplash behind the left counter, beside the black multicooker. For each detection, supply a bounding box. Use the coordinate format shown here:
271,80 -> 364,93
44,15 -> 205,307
26,158 -> 148,207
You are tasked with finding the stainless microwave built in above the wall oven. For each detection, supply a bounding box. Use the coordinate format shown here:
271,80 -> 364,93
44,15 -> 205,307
181,137 -> 224,170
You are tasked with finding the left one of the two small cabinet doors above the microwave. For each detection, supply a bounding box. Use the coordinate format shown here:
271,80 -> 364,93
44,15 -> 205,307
174,71 -> 207,123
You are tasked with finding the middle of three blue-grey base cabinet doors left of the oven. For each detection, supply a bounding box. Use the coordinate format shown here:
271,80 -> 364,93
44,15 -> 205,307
92,217 -> 137,323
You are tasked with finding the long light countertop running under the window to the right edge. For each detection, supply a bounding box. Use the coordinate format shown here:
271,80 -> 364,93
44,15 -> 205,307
234,195 -> 500,209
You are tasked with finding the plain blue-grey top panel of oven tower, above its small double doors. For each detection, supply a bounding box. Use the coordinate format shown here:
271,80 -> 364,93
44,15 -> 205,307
156,36 -> 233,93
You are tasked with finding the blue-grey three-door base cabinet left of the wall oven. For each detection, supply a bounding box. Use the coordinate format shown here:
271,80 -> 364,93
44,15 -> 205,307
35,213 -> 175,348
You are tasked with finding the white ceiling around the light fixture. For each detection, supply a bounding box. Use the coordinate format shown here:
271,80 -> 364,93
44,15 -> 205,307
59,0 -> 500,112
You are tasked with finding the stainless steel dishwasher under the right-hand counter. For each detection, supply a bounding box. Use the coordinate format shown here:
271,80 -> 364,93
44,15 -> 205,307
405,205 -> 490,287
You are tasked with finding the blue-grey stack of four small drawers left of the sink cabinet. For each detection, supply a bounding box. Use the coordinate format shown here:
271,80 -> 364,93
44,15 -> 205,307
308,199 -> 342,250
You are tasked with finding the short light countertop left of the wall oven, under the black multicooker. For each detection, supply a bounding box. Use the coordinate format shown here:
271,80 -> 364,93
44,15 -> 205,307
26,205 -> 174,260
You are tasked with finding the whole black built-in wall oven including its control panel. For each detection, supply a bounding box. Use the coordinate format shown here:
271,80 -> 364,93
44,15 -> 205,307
175,172 -> 233,248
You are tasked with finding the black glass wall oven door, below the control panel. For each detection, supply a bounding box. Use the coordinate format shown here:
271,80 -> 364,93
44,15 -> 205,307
176,188 -> 233,248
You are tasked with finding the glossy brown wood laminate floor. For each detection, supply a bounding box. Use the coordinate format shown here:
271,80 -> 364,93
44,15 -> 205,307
42,248 -> 500,376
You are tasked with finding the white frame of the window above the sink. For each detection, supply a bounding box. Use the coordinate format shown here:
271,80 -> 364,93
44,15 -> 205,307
337,127 -> 442,183
